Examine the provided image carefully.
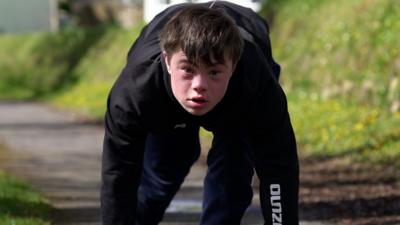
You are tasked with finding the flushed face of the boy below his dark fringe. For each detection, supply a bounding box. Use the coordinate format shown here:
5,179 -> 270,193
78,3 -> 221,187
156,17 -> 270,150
164,51 -> 234,116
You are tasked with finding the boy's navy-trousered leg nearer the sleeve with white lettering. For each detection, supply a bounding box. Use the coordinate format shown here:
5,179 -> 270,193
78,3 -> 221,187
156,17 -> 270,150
200,130 -> 254,225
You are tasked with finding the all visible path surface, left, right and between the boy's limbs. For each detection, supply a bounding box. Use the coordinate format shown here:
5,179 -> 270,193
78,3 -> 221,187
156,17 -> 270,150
0,102 -> 400,225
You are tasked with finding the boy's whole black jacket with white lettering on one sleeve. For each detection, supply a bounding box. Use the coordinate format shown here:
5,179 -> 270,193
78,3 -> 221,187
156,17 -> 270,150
101,1 -> 298,225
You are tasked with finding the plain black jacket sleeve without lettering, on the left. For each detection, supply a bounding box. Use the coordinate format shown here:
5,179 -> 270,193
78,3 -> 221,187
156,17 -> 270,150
101,77 -> 146,225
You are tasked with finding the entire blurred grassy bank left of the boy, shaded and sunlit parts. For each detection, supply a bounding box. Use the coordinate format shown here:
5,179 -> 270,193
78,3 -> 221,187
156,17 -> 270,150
0,25 -> 143,118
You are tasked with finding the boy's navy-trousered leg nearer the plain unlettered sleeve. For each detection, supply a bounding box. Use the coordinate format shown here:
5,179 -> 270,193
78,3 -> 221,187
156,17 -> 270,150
137,127 -> 200,225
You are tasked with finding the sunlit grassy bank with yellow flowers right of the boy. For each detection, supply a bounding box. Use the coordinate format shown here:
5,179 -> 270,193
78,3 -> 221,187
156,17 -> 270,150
263,0 -> 400,169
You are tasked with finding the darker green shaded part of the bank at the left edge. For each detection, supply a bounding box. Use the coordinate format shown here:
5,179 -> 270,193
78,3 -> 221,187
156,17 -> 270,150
0,27 -> 106,99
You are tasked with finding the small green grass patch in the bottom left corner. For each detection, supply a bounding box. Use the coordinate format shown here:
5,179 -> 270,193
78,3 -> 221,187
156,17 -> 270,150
0,171 -> 51,225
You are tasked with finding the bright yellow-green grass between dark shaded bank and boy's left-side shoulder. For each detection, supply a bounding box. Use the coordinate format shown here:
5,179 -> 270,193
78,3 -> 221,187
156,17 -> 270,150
49,25 -> 142,120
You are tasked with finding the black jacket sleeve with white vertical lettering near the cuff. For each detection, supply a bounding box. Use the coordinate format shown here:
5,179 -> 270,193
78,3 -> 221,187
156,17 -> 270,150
254,68 -> 299,225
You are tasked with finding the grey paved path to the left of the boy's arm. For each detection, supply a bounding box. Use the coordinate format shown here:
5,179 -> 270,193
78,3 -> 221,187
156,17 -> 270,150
0,103 -> 102,225
